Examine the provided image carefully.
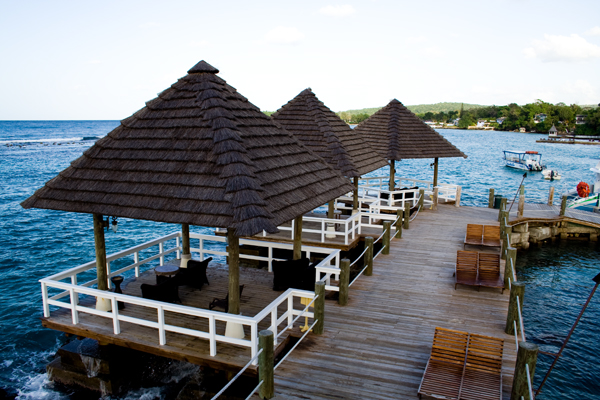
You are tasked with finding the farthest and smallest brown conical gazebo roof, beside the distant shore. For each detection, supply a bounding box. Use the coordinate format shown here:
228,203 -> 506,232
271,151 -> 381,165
354,99 -> 467,160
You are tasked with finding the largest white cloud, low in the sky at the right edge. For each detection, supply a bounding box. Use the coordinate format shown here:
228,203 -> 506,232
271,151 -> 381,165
523,34 -> 600,62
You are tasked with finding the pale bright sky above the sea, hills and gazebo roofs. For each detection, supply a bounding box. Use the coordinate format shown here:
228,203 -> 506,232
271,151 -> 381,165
0,0 -> 600,120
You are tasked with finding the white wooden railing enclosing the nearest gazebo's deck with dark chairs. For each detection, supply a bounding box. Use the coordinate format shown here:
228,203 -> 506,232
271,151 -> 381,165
40,232 -> 340,358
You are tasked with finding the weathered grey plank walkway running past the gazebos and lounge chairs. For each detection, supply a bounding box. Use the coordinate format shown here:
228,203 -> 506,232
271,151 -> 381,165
268,205 -> 526,400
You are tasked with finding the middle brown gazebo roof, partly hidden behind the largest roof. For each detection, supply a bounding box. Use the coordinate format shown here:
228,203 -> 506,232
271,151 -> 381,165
271,88 -> 388,178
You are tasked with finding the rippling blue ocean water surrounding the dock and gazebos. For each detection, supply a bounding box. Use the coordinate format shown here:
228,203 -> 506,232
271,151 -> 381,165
0,121 -> 600,399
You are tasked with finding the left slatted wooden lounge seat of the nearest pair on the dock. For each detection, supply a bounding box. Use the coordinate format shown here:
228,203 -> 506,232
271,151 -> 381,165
418,327 -> 469,399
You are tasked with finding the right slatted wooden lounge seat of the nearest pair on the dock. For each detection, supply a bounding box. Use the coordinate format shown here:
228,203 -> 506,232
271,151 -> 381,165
460,333 -> 504,400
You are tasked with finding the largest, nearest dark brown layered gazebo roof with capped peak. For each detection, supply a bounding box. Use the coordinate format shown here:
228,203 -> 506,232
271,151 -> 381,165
21,61 -> 352,236
